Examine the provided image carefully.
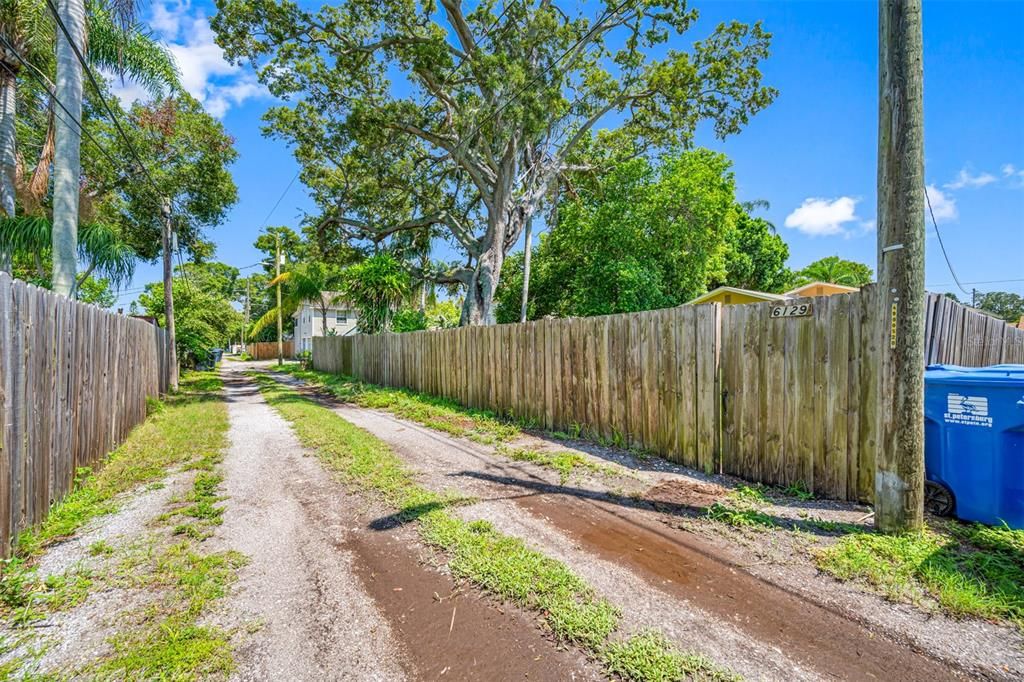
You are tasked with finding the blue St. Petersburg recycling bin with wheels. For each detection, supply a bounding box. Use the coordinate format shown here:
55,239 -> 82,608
925,365 -> 1024,528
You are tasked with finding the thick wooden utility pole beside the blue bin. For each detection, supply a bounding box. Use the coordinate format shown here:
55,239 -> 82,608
874,0 -> 926,532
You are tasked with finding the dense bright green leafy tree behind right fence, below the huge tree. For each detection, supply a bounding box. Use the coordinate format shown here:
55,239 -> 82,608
498,150 -> 740,322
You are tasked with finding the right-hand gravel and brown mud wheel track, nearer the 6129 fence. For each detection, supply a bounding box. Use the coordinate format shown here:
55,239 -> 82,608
325,399 -> 962,682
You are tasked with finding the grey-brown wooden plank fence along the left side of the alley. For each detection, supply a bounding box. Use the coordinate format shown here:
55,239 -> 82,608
0,272 -> 168,556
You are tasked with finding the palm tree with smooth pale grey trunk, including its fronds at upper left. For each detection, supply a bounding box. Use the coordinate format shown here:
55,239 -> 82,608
43,0 -> 176,296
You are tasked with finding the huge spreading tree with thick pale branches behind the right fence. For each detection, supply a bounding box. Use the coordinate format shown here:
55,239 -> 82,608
213,0 -> 775,324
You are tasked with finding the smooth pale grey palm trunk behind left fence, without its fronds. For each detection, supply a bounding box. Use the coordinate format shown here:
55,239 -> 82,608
51,0 -> 85,296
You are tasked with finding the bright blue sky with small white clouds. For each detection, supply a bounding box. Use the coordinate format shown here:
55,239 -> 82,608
119,0 -> 1024,305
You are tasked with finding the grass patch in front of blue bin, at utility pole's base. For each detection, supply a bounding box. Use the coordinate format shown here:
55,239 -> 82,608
815,521 -> 1024,630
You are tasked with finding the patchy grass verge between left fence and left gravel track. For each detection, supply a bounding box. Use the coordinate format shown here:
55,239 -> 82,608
0,372 -> 245,679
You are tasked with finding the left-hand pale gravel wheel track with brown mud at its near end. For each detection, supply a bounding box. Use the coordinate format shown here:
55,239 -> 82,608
217,367 -> 599,682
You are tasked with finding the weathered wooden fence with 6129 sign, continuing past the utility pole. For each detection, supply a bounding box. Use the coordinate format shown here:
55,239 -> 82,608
313,286 -> 1024,502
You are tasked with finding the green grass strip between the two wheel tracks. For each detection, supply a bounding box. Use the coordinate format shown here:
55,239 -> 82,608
251,373 -> 736,682
